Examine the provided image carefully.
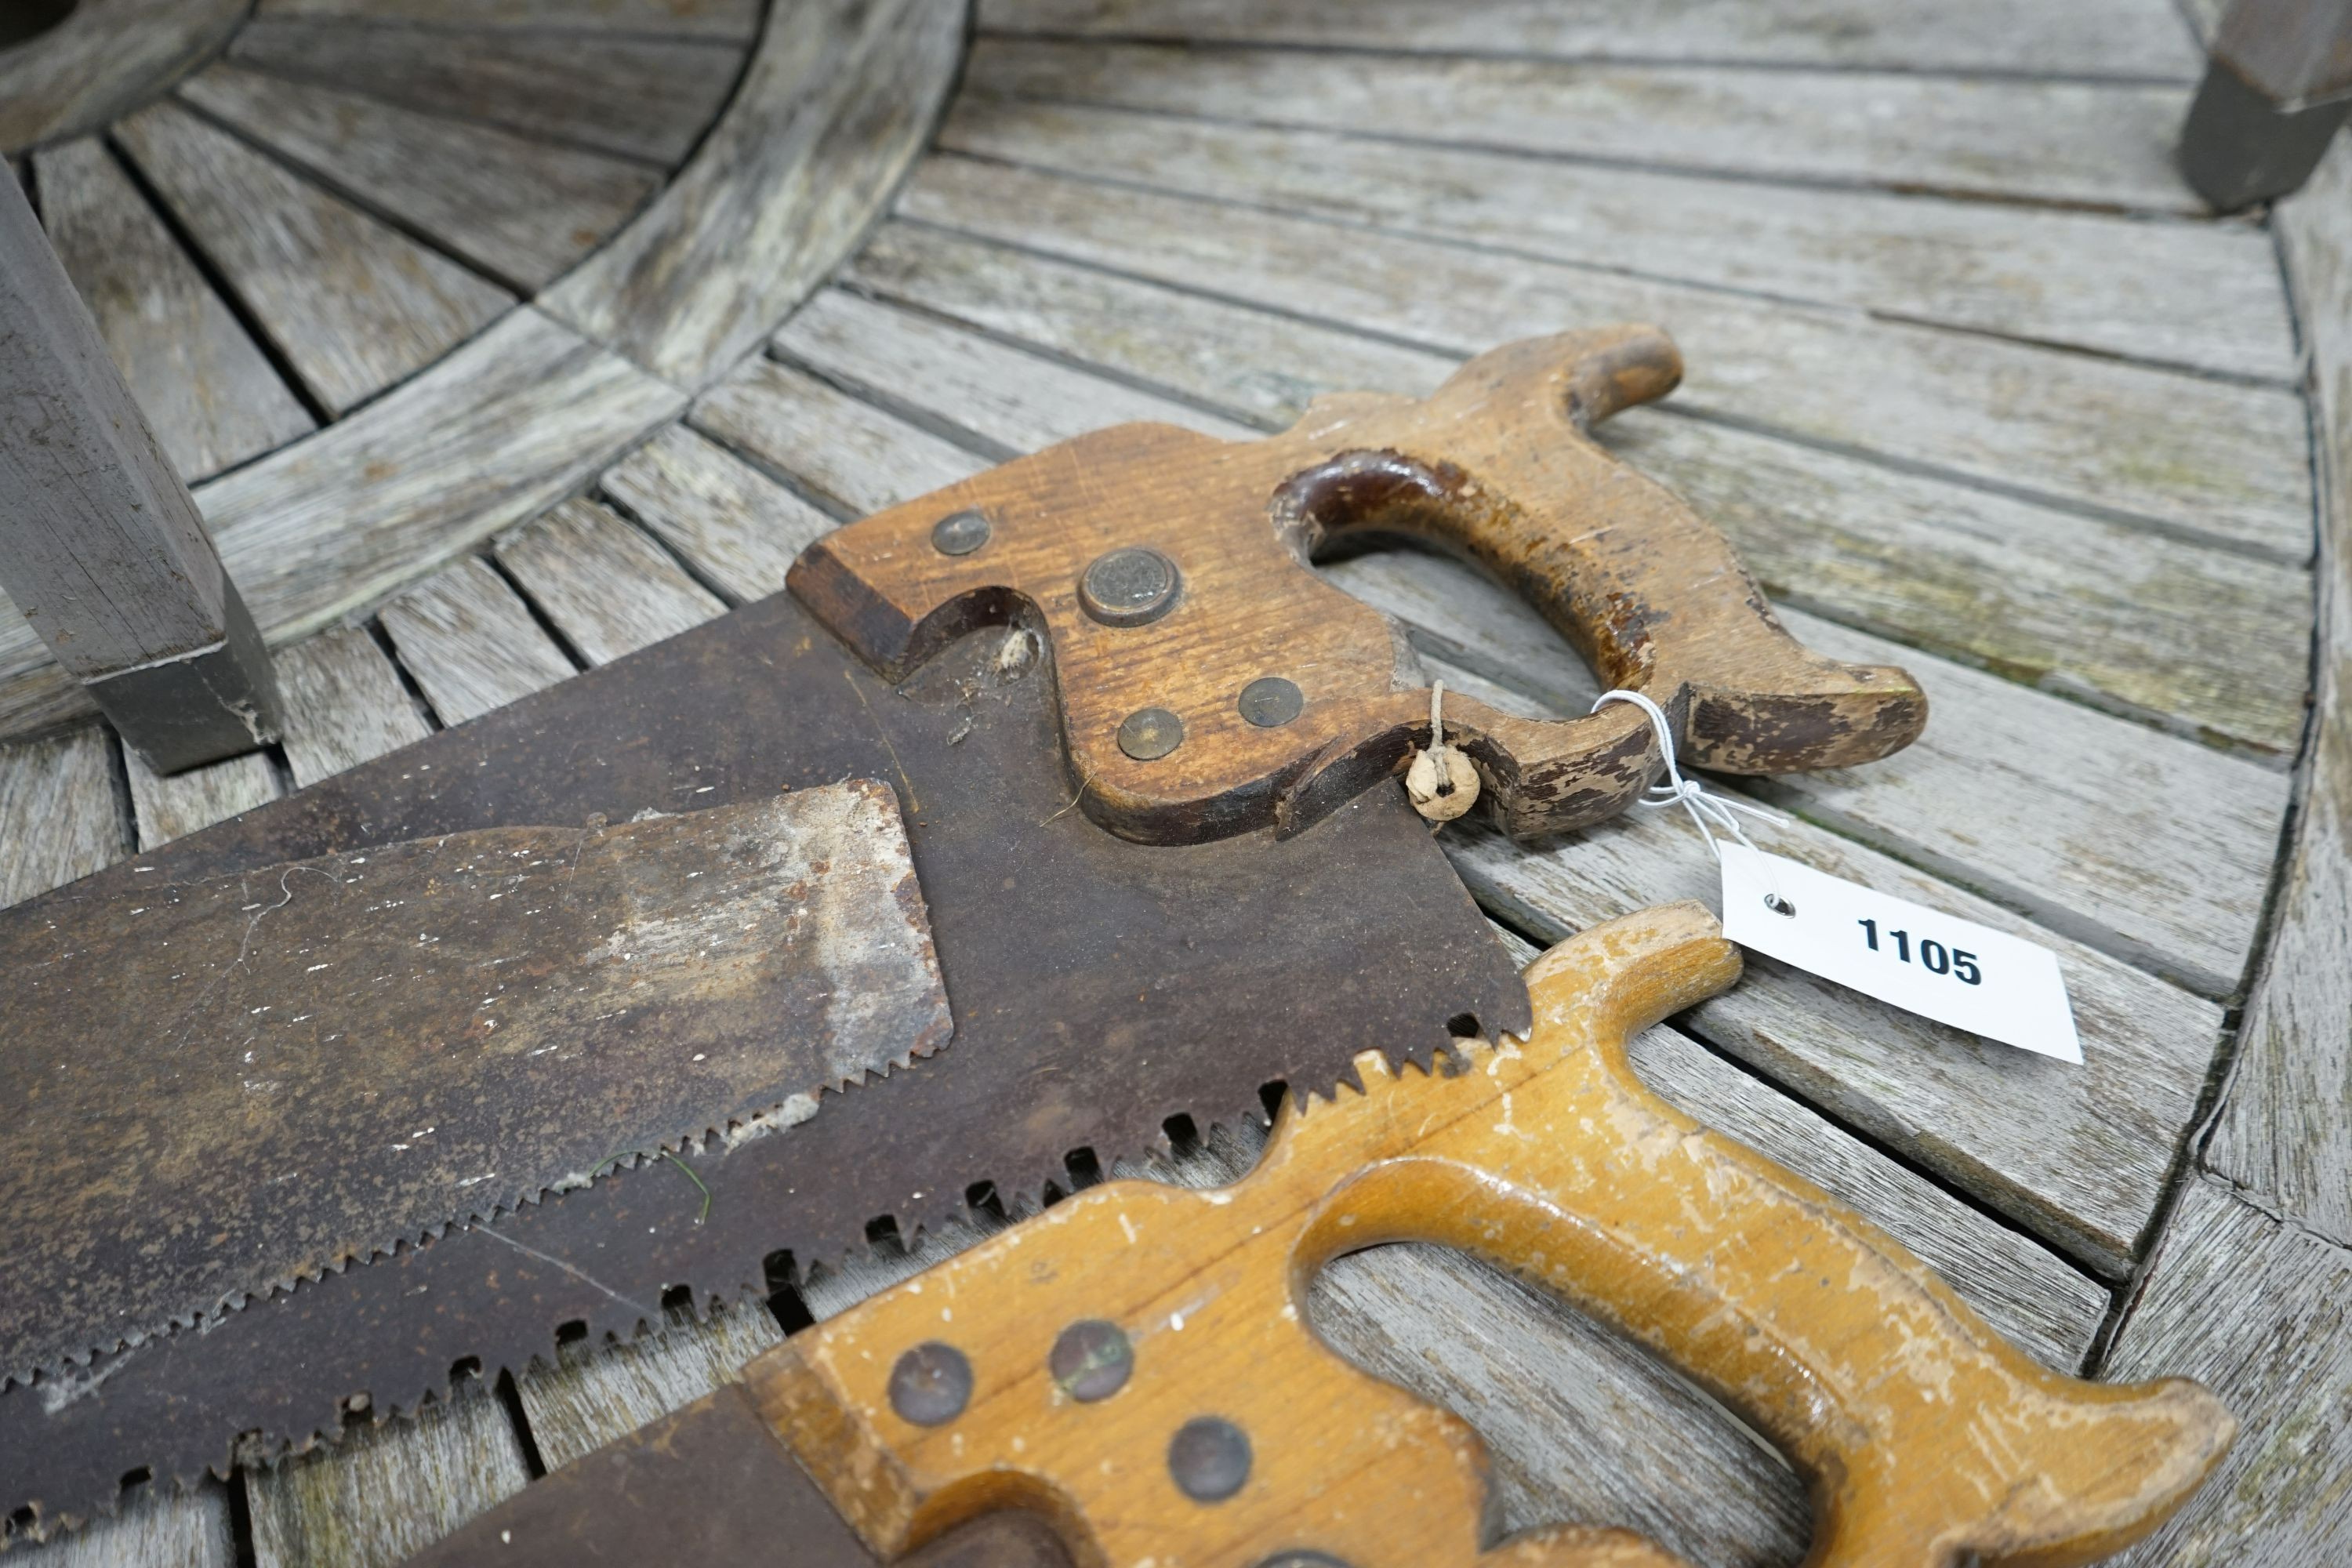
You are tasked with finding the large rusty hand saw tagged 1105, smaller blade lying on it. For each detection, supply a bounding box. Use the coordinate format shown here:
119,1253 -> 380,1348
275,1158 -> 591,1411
0,327 -> 1926,1530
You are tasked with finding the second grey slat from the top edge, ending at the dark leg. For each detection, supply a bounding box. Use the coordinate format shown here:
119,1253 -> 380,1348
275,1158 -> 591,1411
971,38 -> 2204,216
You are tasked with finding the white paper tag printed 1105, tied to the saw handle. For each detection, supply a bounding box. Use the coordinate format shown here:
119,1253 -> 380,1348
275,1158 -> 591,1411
1719,841 -> 2082,1062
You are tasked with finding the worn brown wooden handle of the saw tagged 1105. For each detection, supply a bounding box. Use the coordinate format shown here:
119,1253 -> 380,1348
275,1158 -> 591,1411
790,327 -> 1926,844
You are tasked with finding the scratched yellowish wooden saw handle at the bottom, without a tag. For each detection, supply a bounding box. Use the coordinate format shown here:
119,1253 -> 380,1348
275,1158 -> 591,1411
746,905 -> 2234,1568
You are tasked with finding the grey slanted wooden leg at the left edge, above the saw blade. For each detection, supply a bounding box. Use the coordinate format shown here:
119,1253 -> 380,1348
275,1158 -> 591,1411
0,159 -> 278,774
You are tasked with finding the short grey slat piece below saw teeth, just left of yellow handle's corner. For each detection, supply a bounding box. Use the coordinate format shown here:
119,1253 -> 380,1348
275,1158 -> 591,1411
515,1300 -> 783,1469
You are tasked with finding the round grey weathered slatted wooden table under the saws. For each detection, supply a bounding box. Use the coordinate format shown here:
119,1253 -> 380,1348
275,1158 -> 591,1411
0,0 -> 2352,1568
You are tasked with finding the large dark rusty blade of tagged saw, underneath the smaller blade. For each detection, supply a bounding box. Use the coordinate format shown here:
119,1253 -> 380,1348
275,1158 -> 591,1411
0,597 -> 1529,1530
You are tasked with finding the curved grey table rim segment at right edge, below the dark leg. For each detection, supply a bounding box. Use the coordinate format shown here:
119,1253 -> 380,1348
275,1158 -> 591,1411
2206,143 -> 2352,1241
